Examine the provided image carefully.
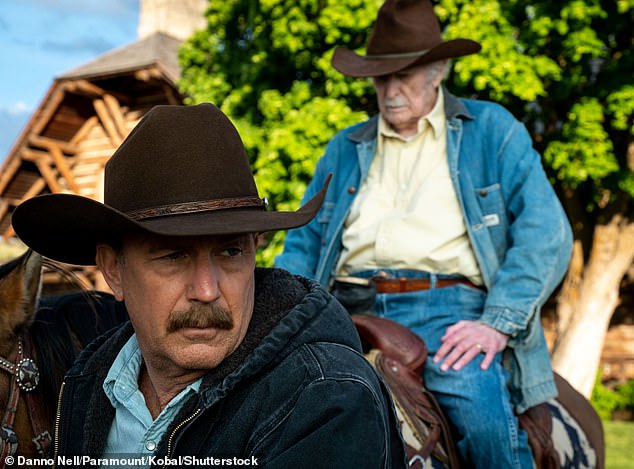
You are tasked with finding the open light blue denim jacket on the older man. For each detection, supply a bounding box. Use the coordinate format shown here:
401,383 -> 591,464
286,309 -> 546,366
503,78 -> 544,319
275,91 -> 572,412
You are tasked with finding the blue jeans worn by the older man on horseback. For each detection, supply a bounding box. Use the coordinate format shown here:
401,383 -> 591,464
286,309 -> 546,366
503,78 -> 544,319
354,269 -> 533,469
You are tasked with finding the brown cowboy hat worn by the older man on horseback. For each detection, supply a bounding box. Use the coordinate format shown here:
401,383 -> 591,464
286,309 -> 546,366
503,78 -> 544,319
332,0 -> 481,77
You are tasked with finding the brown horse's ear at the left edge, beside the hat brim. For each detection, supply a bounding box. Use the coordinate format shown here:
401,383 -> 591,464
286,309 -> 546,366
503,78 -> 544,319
0,249 -> 42,340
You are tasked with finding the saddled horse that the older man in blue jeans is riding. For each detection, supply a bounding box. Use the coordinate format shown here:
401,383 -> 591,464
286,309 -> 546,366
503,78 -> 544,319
352,314 -> 605,469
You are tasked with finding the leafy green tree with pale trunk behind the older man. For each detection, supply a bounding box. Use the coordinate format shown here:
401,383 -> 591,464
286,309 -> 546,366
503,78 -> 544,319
181,0 -> 634,395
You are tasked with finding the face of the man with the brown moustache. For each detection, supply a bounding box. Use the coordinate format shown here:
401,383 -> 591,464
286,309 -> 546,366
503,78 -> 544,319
97,234 -> 255,375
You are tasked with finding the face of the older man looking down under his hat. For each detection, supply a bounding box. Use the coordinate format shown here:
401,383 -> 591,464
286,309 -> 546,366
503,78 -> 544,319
374,63 -> 445,137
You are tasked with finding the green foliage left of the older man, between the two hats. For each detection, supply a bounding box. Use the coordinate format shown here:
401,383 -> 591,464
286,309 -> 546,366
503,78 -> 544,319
181,0 -> 381,265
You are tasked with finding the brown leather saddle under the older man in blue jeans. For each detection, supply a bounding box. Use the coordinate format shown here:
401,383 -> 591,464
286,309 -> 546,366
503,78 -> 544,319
352,315 -> 560,469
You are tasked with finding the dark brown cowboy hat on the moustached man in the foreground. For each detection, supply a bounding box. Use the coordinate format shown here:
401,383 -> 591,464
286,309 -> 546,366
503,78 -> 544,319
12,104 -> 326,265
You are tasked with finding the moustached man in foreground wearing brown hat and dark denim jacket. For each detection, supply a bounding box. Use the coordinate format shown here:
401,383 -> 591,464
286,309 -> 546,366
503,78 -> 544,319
13,104 -> 405,469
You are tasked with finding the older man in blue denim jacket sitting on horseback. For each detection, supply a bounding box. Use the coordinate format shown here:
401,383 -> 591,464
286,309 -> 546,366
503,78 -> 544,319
276,0 -> 571,469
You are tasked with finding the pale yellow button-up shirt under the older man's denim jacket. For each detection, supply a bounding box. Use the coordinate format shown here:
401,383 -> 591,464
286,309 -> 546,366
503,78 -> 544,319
337,90 -> 482,285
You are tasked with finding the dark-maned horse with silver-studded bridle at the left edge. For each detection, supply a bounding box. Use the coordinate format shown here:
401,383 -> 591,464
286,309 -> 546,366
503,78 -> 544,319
0,250 -> 127,462
